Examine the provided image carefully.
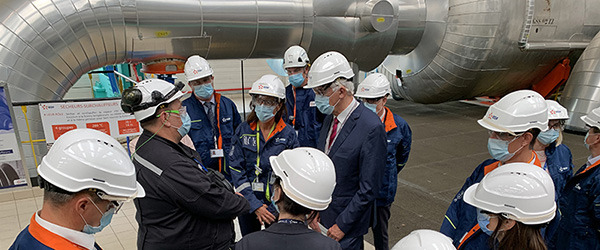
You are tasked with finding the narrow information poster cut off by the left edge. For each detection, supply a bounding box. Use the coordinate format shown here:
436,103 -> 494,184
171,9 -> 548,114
0,84 -> 29,189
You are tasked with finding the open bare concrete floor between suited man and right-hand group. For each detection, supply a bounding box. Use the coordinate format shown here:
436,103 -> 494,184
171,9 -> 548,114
365,99 -> 589,246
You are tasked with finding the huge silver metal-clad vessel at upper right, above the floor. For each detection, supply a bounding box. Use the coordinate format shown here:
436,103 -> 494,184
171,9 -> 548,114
383,0 -> 600,103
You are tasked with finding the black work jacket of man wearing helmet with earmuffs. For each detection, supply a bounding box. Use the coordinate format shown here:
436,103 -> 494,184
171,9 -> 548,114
133,130 -> 250,250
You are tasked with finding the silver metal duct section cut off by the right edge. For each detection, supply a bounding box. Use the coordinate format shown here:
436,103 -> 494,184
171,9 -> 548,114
561,32 -> 600,132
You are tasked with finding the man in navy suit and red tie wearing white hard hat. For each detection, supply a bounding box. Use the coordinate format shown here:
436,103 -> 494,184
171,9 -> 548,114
306,51 -> 387,249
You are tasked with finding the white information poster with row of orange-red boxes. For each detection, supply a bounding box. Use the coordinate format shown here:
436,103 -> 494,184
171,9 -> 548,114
39,100 -> 142,143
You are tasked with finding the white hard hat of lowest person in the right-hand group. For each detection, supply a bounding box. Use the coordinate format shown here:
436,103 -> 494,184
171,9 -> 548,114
464,162 -> 556,225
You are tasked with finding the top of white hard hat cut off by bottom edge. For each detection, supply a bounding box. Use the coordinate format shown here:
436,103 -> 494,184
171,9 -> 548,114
392,229 -> 456,250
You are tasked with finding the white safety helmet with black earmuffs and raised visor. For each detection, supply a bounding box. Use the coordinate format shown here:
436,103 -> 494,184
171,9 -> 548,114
121,79 -> 184,121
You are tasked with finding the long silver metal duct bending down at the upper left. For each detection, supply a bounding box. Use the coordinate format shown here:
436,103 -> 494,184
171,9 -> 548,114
0,0 -> 425,102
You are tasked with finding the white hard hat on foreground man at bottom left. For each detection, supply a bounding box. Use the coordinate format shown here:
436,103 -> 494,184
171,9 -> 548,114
37,128 -> 146,200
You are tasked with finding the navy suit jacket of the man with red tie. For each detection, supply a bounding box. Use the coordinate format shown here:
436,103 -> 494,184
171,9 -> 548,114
317,104 -> 387,237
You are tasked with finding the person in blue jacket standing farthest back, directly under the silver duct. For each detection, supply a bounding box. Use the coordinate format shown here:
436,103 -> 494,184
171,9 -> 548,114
283,45 -> 325,148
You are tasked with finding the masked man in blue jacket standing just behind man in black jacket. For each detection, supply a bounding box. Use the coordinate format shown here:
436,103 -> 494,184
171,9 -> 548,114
182,55 -> 242,181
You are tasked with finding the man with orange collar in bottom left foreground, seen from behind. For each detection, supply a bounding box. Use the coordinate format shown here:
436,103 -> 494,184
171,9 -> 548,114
11,129 -> 146,250
